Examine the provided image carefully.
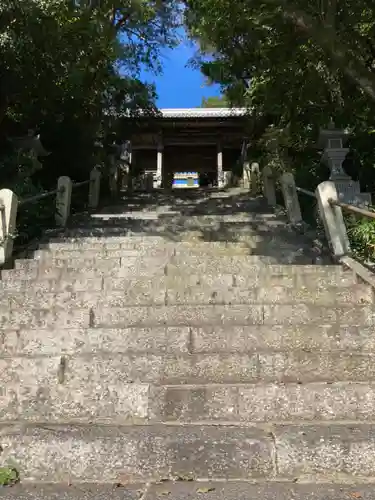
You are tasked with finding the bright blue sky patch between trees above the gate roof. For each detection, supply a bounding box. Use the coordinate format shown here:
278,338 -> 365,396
141,31 -> 220,108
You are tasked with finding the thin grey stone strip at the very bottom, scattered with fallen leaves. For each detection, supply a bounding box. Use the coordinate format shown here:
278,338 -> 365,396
1,484 -> 375,500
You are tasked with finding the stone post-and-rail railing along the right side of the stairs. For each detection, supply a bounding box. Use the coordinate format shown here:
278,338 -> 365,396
262,167 -> 375,283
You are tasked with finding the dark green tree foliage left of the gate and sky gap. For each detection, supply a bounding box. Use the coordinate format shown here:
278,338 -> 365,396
0,0 -> 179,249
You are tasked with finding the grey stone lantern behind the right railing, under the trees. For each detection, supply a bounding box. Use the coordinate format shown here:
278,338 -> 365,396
318,123 -> 371,206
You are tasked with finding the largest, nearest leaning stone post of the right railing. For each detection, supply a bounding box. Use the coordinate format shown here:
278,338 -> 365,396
315,181 -> 350,257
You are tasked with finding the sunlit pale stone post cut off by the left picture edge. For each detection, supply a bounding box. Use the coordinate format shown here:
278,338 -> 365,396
0,189 -> 18,265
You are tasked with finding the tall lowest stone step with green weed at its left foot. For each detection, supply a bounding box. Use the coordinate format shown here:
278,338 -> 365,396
1,423 -> 375,482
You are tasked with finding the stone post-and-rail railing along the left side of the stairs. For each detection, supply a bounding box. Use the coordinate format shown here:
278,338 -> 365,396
0,167 -> 122,266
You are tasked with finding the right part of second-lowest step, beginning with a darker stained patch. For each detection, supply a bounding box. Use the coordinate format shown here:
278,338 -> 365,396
153,382 -> 375,423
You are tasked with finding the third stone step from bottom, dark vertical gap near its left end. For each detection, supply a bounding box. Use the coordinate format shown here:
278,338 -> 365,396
0,351 -> 375,388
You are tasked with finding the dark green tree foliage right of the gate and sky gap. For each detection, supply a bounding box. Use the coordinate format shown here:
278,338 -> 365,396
185,0 -> 375,255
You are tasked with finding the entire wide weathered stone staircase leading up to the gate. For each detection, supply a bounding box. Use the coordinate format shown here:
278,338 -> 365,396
0,190 -> 375,500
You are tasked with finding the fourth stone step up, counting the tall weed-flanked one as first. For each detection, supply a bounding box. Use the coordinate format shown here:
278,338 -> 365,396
1,324 -> 375,356
